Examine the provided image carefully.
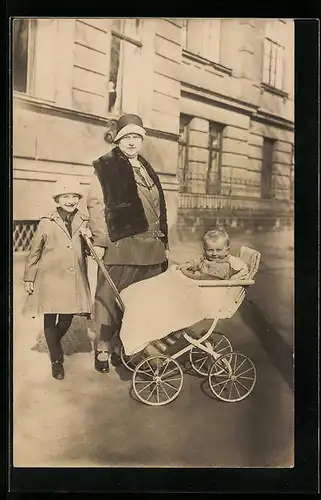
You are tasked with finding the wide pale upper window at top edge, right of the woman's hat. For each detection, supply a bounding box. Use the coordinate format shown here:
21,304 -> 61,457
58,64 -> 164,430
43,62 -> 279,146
182,19 -> 221,63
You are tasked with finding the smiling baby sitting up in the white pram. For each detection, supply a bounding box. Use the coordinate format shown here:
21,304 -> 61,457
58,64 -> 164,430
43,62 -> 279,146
178,229 -> 248,280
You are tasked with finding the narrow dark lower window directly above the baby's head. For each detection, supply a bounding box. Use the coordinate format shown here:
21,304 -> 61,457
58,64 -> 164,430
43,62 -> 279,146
205,123 -> 223,194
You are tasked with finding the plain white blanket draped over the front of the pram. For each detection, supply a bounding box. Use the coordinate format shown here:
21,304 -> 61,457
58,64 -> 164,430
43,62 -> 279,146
120,267 -> 226,355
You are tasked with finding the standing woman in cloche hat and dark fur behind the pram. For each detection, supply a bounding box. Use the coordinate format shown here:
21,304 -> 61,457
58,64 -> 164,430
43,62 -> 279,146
87,114 -> 169,372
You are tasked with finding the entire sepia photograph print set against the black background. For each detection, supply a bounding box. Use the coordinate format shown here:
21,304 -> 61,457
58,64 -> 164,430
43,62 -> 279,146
10,17 -> 295,469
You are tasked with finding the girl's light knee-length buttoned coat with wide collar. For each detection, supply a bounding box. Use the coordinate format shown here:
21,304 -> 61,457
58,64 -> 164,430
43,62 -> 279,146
23,211 -> 92,315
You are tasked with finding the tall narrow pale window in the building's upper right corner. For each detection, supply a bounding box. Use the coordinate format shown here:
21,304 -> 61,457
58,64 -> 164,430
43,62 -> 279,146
263,22 -> 284,90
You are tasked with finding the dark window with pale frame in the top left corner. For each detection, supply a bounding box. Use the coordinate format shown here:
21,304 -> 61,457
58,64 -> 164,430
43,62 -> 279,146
12,19 -> 35,93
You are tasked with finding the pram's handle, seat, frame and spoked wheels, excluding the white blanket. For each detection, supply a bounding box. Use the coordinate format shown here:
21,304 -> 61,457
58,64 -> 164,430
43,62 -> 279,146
84,236 -> 261,406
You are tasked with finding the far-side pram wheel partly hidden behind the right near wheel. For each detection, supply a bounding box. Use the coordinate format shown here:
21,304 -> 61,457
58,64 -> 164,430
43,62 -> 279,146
189,332 -> 232,377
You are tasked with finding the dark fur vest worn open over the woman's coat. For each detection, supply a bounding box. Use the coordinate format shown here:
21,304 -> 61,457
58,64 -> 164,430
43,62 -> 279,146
93,146 -> 168,244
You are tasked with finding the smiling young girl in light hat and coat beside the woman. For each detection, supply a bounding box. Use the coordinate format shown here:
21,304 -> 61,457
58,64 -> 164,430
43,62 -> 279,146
23,180 -> 92,380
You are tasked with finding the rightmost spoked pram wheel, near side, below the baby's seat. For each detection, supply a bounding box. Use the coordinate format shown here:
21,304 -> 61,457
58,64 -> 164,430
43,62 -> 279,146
208,352 -> 256,403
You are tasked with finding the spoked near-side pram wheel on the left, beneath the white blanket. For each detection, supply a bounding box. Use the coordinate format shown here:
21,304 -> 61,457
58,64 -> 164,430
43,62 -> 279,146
133,355 -> 183,406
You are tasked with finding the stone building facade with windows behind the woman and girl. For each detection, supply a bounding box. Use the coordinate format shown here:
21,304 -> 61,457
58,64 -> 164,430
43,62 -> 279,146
12,18 -> 294,251
